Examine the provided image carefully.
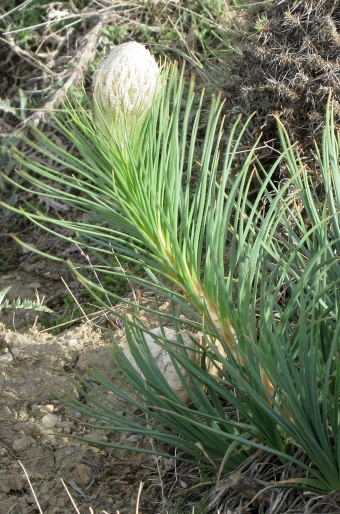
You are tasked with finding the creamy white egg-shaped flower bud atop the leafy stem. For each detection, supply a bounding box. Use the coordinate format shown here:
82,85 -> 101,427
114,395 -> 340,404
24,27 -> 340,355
93,42 -> 160,140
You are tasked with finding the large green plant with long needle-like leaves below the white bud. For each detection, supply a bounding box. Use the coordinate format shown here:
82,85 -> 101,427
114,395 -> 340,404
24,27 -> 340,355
1,63 -> 340,492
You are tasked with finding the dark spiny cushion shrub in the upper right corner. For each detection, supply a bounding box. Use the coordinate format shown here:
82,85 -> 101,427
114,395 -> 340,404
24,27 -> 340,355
225,0 -> 340,169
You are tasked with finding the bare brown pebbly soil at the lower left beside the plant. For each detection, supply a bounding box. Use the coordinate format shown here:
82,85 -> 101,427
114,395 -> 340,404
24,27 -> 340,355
0,306 -> 174,514
